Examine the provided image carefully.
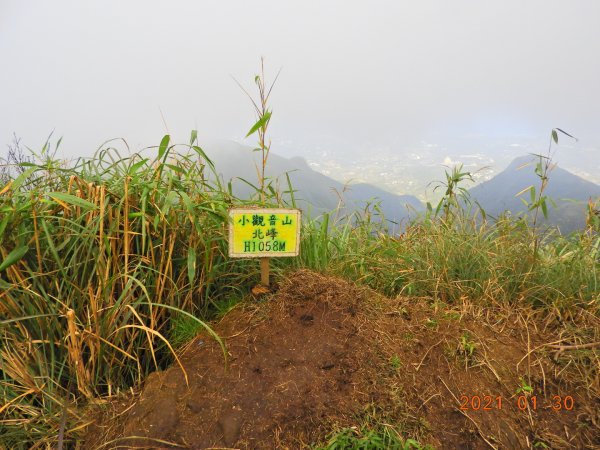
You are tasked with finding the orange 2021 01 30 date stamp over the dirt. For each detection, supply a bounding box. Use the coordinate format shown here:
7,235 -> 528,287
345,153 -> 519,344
459,395 -> 575,411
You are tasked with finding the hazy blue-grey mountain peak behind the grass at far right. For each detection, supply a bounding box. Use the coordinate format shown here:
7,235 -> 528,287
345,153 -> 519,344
469,155 -> 600,234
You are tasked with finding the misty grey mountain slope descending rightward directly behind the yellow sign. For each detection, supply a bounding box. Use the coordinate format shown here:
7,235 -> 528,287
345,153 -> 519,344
203,141 -> 424,229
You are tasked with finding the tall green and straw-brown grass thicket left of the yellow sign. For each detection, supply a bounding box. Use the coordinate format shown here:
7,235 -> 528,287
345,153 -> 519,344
0,135 -> 270,448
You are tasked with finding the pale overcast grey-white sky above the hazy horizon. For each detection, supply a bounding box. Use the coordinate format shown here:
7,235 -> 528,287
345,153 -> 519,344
0,0 -> 600,155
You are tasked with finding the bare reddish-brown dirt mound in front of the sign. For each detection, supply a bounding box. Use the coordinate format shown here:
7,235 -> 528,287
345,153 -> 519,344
86,271 -> 600,449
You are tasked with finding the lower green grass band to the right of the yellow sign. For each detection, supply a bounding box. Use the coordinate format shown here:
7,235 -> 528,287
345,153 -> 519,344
296,192 -> 600,314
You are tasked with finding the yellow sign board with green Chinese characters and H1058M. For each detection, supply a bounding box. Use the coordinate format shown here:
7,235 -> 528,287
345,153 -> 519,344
229,208 -> 300,258
